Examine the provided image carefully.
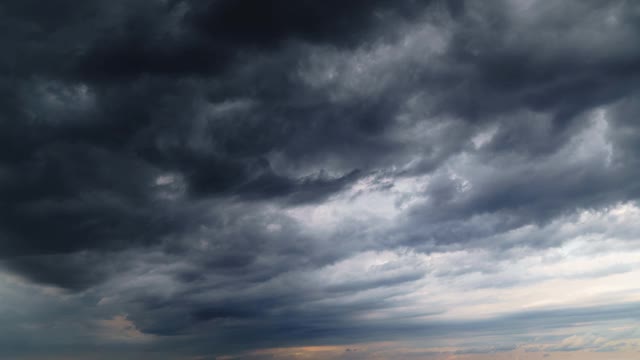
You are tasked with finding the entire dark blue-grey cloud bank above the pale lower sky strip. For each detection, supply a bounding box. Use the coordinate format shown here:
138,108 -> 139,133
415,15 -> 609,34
0,0 -> 640,354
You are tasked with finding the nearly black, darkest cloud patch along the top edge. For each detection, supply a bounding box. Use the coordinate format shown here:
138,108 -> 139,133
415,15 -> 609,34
67,0 -> 430,81
